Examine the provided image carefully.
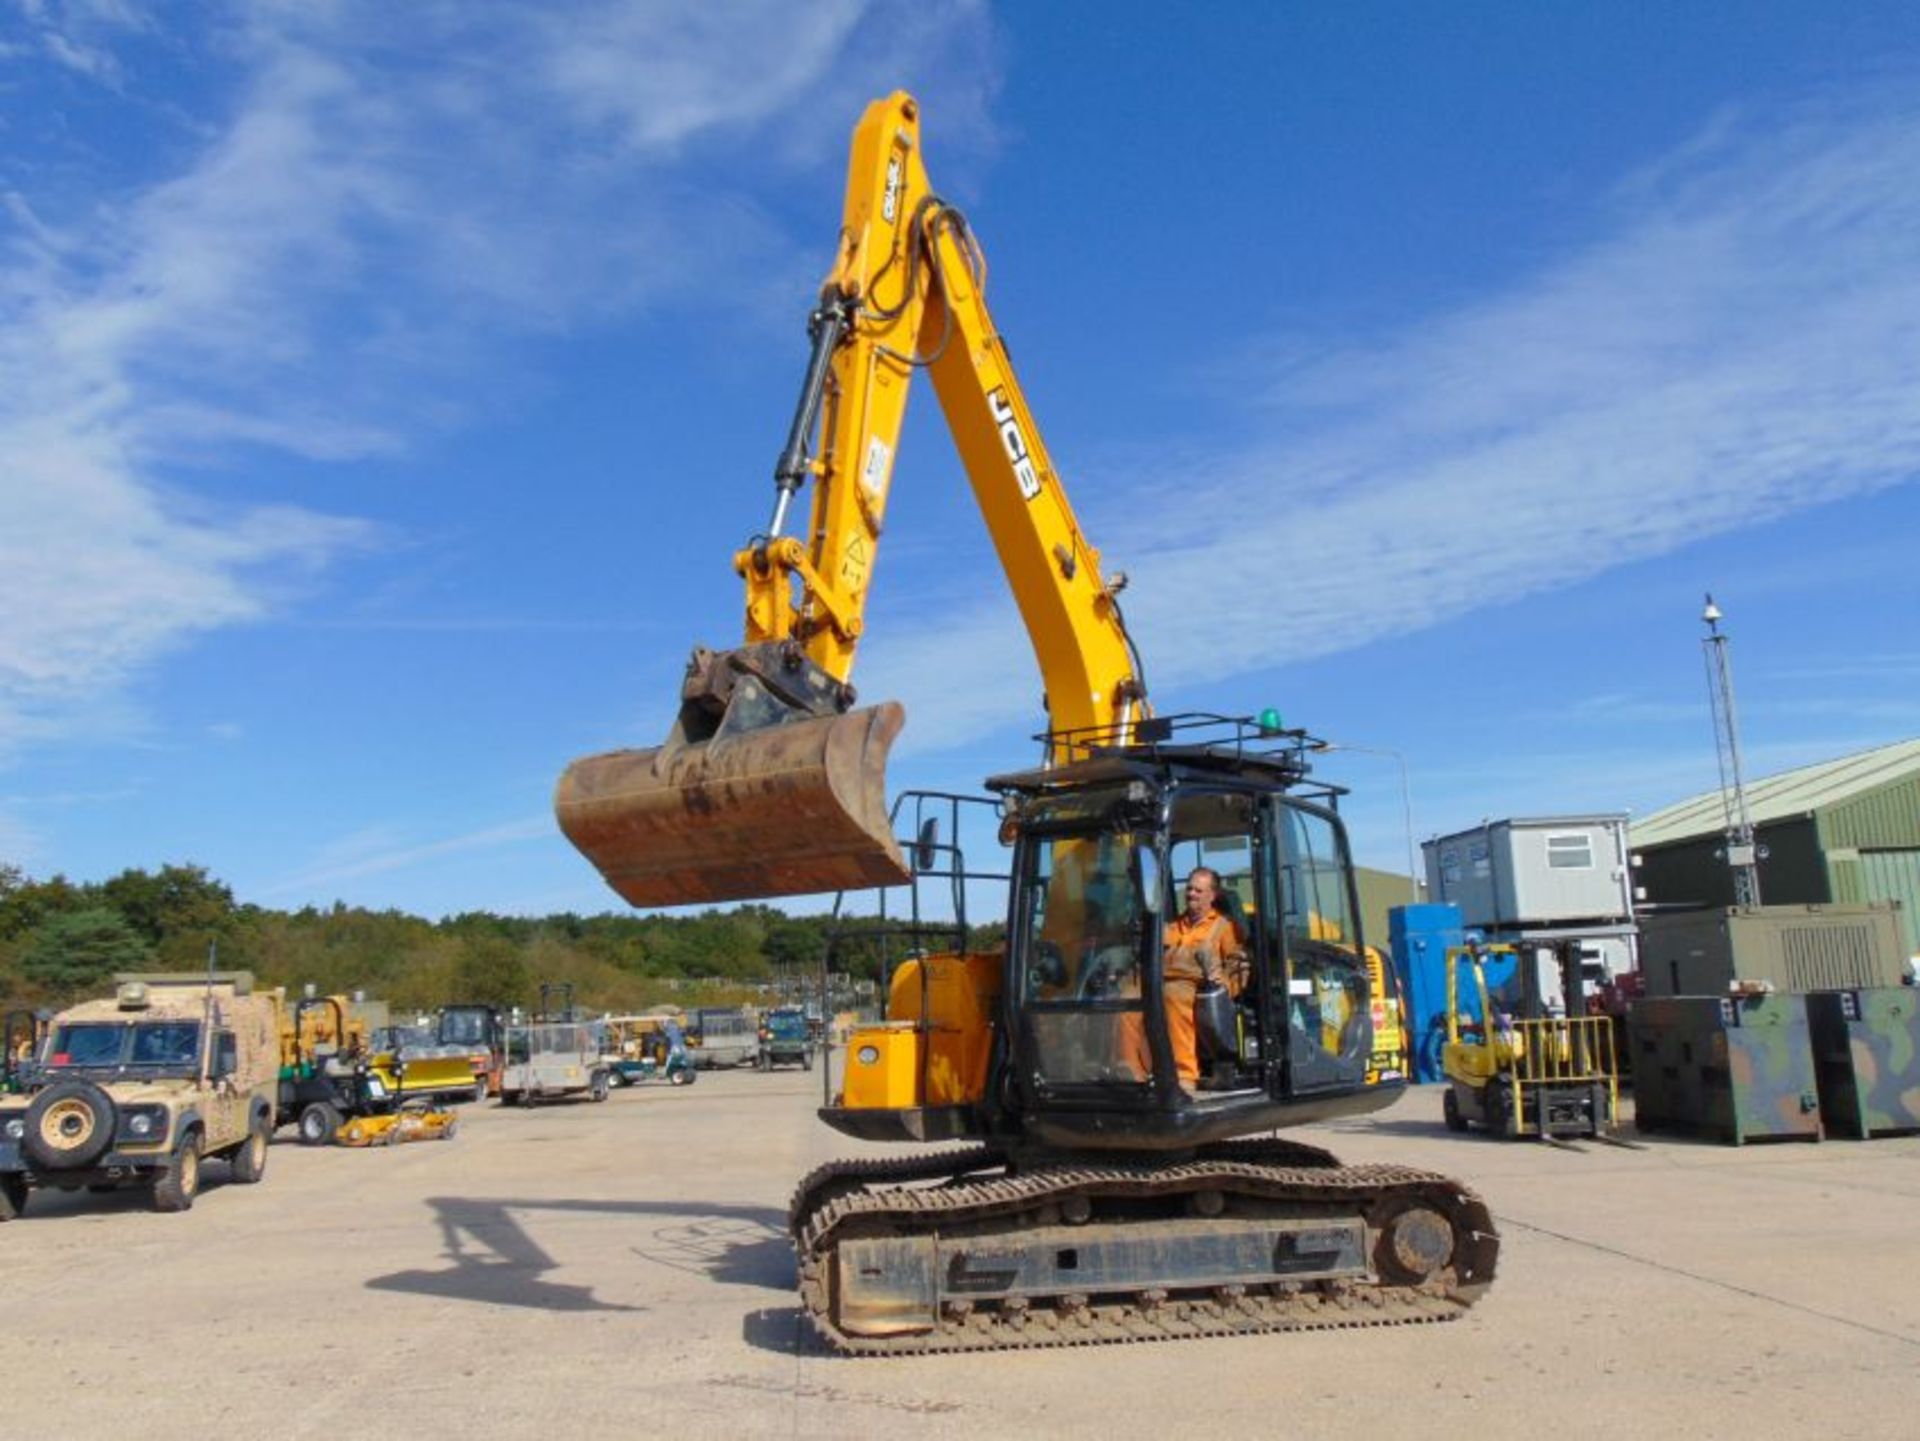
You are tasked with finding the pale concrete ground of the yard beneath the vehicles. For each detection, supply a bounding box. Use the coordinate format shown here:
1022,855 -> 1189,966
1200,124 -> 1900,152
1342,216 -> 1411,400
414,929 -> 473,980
0,1071 -> 1920,1441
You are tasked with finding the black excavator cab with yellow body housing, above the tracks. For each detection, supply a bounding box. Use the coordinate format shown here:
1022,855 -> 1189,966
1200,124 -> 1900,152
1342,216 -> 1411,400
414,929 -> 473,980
822,725 -> 1402,1151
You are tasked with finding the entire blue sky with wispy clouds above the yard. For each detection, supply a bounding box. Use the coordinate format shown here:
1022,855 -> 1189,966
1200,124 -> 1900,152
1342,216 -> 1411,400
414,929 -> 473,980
0,0 -> 1920,915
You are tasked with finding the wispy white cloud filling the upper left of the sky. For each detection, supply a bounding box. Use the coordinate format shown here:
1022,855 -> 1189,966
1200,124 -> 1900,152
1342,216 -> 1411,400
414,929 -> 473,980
0,0 -> 991,767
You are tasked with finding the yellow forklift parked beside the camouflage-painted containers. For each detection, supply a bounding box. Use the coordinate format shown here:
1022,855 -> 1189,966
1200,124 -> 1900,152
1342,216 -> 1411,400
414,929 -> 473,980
1440,940 -> 1630,1146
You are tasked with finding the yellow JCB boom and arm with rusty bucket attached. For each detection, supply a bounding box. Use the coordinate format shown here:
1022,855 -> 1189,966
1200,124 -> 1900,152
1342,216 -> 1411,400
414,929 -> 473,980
555,92 -> 1146,906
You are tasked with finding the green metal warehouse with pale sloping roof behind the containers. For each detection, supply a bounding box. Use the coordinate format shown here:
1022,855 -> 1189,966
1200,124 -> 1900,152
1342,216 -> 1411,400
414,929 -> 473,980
1628,741 -> 1920,952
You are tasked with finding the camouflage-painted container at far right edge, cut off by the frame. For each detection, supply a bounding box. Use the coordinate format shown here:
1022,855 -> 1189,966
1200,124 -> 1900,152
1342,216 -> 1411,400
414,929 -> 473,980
1807,986 -> 1920,1140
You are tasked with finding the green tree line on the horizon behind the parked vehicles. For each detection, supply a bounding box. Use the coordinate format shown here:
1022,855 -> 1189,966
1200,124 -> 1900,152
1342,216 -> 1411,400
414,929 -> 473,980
0,865 -> 990,1011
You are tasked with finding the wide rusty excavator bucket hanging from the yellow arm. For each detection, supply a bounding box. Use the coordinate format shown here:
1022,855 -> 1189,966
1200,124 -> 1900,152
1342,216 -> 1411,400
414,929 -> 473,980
553,643 -> 908,906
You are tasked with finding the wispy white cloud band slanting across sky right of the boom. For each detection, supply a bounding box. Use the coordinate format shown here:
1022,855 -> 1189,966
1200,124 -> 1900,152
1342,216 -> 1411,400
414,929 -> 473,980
862,90 -> 1920,746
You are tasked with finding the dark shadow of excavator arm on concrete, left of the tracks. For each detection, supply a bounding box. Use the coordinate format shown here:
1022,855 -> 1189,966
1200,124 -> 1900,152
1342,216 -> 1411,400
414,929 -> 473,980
367,1195 -> 793,1312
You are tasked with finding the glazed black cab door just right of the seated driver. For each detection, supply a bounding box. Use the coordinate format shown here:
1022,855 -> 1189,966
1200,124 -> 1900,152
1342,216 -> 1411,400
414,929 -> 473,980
1269,796 -> 1373,1096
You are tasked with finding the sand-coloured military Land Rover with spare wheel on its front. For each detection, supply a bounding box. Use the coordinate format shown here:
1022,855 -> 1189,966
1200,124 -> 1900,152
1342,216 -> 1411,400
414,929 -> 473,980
0,971 -> 280,1220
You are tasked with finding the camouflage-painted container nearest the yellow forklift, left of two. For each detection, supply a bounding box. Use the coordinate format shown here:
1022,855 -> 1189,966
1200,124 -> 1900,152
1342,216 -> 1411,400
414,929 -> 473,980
1628,994 -> 1824,1146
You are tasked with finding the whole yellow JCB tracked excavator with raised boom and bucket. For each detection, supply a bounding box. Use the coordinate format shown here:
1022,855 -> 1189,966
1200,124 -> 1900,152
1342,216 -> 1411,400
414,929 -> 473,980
555,92 -> 1498,1353
